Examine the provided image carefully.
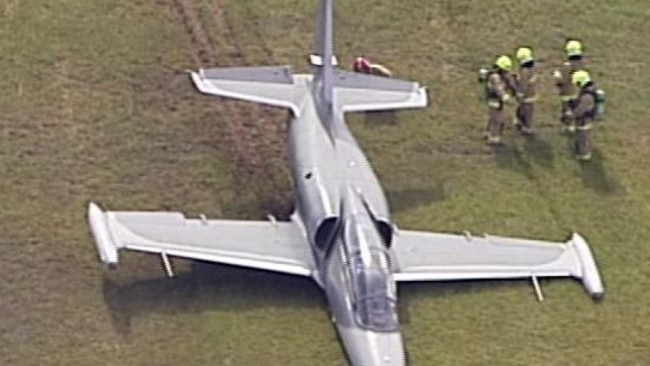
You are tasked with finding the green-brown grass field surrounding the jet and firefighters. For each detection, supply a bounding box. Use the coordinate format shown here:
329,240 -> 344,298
0,0 -> 650,366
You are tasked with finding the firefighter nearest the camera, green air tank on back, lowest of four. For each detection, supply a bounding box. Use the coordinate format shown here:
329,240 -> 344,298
571,70 -> 598,161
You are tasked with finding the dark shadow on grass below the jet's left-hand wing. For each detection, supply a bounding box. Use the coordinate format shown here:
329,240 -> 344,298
102,261 -> 327,335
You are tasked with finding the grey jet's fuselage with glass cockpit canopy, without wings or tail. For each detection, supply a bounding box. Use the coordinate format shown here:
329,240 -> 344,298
289,75 -> 405,366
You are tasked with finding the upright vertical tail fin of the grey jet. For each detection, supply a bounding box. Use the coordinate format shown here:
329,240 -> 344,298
312,0 -> 335,106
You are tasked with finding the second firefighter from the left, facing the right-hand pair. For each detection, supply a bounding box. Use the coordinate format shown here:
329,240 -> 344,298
514,47 -> 537,134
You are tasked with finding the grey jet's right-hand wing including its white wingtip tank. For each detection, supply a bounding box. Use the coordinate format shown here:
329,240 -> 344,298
384,231 -> 604,297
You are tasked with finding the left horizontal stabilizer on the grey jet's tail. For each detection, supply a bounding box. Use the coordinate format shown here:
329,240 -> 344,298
190,66 -> 298,113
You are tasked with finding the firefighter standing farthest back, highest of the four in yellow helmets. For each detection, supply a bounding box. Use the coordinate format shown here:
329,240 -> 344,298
553,39 -> 585,133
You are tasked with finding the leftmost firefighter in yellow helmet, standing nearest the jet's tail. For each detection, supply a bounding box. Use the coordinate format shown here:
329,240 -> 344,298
485,55 -> 512,145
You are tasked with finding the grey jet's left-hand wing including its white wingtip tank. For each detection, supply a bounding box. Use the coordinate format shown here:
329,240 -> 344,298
88,203 -> 314,276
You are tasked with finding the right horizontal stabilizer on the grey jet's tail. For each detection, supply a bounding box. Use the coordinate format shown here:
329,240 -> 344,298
334,70 -> 427,112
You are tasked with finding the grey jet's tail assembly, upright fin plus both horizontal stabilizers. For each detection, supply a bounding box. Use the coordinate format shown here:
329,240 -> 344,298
191,0 -> 427,114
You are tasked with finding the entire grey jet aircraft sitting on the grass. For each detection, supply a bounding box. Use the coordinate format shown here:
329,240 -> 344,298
88,0 -> 604,366
